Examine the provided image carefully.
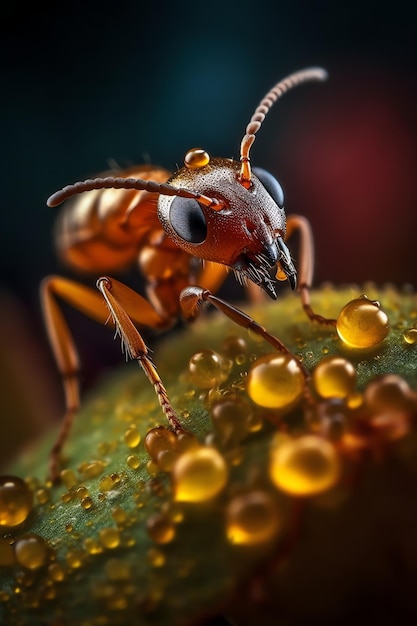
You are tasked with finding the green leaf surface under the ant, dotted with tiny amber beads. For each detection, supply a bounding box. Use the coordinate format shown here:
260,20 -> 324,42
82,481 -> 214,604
0,285 -> 417,626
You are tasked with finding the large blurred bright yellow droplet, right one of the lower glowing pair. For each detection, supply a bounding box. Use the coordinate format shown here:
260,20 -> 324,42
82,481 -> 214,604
269,435 -> 340,496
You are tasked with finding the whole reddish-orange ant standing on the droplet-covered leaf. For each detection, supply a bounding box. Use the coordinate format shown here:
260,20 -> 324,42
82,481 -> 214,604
41,67 -> 335,482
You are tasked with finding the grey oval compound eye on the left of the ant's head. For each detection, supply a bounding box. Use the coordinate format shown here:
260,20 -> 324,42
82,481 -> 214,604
169,196 -> 207,243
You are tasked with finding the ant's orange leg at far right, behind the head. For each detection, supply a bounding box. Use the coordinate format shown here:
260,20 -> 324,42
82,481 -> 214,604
286,215 -> 336,326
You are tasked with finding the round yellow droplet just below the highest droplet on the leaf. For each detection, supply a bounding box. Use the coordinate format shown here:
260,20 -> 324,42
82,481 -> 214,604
313,356 -> 356,398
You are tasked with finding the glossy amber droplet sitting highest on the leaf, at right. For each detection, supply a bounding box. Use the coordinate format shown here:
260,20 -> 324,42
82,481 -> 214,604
336,297 -> 389,348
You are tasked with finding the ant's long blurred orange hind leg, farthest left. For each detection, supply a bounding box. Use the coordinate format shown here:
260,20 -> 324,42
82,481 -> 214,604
40,276 -> 172,483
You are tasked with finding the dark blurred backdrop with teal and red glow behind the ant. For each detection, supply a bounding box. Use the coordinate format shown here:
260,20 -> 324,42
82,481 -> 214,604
0,0 -> 417,459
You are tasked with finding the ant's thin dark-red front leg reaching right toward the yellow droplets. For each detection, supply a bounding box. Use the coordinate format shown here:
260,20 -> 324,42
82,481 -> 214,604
180,286 -> 310,380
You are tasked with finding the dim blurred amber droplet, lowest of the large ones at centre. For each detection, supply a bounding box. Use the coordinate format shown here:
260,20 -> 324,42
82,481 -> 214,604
226,490 -> 282,546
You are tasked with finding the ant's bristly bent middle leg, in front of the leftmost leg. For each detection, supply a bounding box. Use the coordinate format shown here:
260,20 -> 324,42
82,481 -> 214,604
97,276 -> 184,433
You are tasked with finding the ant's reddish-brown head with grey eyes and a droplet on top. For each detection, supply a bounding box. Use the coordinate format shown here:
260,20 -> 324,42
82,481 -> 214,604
158,148 -> 290,298
